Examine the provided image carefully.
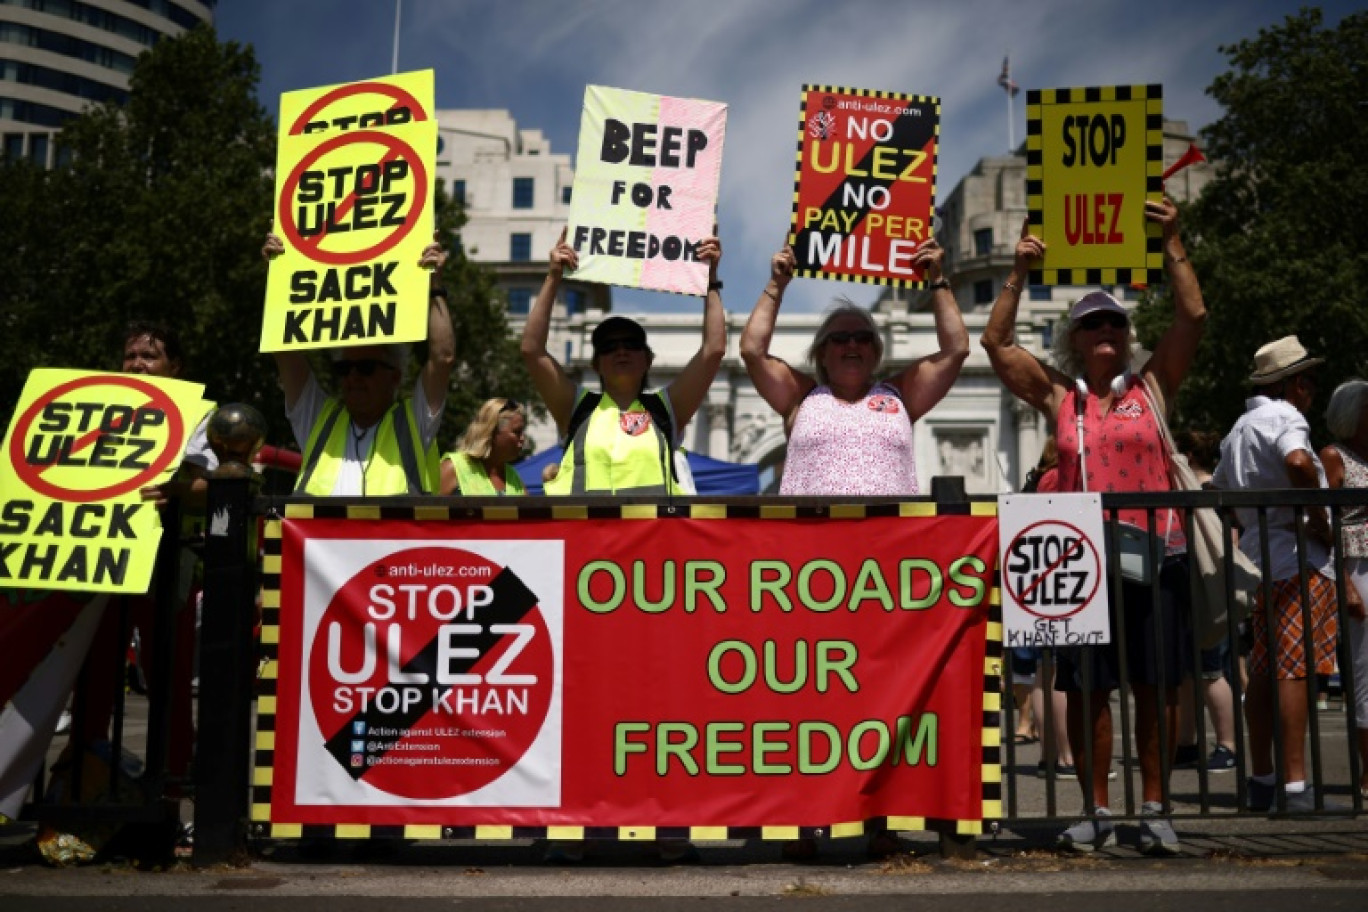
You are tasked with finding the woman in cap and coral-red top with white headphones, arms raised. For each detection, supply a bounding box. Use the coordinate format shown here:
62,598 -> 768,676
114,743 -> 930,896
982,198 -> 1207,855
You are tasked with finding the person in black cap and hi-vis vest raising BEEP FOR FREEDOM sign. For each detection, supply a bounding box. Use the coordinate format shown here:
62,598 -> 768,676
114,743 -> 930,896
523,231 -> 726,494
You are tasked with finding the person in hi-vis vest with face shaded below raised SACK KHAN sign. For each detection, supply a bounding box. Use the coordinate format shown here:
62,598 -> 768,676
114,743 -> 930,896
261,235 -> 456,496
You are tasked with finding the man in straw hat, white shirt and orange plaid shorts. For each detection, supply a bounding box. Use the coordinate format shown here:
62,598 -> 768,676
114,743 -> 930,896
1212,336 -> 1364,811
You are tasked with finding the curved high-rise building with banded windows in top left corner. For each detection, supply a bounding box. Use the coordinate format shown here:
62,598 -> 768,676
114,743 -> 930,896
0,0 -> 218,167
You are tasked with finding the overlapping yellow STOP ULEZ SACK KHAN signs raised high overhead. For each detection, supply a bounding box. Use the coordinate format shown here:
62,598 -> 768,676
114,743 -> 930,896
261,70 -> 436,351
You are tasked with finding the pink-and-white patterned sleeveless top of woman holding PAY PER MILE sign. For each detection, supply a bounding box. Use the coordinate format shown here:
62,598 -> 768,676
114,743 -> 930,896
778,383 -> 917,495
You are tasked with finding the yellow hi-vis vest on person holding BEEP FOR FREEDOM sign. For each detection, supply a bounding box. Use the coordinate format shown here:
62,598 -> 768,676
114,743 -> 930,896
544,391 -> 679,494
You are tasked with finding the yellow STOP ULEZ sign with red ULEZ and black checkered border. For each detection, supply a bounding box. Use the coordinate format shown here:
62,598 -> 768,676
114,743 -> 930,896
1026,85 -> 1164,284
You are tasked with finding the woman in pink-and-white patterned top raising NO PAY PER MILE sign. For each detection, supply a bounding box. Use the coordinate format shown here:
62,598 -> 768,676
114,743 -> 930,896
741,239 -> 969,495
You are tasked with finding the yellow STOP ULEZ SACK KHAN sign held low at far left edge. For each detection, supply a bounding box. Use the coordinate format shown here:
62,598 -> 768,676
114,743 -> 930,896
0,369 -> 211,593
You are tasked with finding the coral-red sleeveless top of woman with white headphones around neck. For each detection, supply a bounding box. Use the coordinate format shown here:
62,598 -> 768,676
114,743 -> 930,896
1055,376 -> 1186,552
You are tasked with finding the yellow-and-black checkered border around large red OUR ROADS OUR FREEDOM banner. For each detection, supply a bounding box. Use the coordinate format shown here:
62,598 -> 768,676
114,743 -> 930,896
250,502 -> 1003,841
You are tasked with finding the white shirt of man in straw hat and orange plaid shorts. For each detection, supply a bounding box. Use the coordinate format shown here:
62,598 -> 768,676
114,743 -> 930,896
1211,397 -> 1335,581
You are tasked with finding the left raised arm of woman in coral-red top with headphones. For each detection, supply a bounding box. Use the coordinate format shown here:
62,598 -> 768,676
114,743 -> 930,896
978,220 -> 1068,420
